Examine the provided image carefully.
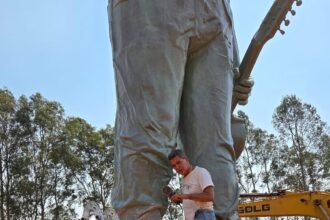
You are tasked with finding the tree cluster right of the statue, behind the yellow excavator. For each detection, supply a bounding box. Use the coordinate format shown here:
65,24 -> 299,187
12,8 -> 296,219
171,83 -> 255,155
237,96 -> 330,193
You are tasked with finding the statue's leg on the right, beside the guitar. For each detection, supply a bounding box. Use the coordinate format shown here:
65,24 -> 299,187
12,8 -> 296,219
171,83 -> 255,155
180,2 -> 239,219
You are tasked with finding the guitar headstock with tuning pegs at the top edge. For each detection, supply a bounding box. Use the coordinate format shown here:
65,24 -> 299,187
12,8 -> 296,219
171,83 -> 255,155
253,0 -> 302,45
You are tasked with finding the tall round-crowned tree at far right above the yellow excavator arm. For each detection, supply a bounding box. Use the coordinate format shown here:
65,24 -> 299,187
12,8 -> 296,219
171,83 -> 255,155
273,95 -> 327,190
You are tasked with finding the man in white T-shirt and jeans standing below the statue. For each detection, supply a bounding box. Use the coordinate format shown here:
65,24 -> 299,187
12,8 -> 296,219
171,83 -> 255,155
168,150 -> 215,220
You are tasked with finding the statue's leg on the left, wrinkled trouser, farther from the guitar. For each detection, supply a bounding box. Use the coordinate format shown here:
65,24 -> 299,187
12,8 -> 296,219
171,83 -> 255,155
109,0 -> 191,220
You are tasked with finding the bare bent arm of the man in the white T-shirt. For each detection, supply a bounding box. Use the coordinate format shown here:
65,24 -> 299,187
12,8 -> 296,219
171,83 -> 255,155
171,186 -> 214,203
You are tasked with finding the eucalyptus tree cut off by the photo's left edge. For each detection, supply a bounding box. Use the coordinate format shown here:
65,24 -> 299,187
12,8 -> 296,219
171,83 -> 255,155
0,89 -> 37,219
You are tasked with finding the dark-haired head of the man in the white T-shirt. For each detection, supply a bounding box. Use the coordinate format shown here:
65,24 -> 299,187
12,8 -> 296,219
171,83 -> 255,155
167,149 -> 192,176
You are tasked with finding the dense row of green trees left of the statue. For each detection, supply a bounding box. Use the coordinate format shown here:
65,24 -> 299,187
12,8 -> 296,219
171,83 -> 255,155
0,89 -> 114,219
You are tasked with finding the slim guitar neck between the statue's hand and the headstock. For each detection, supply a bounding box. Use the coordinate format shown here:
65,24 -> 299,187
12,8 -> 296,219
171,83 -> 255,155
231,38 -> 263,112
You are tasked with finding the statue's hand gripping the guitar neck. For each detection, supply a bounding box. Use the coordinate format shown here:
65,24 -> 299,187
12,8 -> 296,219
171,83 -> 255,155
233,68 -> 254,105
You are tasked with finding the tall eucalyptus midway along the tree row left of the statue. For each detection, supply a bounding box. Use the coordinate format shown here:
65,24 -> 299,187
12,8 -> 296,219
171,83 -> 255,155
29,93 -> 68,219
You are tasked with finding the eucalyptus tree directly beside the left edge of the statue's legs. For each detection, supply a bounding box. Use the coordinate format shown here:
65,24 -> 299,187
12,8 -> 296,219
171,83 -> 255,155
64,117 -> 114,212
